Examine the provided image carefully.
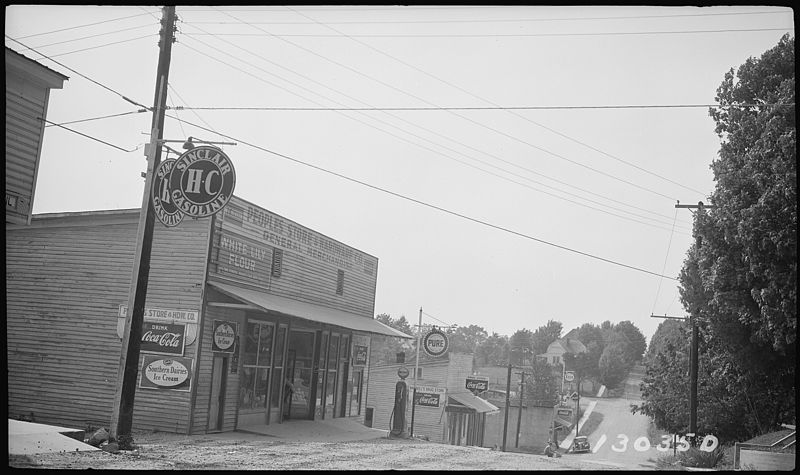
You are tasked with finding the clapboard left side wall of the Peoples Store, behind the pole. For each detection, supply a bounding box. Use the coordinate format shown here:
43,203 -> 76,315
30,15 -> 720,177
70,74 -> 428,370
6,211 -> 208,431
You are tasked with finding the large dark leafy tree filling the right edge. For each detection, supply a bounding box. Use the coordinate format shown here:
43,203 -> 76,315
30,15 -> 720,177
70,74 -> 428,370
635,35 -> 797,440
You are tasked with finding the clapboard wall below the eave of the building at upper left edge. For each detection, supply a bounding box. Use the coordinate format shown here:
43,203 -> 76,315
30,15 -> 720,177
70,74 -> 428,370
6,74 -> 49,224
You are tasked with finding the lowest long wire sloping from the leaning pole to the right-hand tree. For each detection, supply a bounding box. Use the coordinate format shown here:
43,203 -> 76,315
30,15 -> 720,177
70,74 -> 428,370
167,115 -> 677,280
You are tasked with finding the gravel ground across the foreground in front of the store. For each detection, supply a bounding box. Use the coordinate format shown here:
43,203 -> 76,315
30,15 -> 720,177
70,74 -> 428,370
9,433 -> 617,470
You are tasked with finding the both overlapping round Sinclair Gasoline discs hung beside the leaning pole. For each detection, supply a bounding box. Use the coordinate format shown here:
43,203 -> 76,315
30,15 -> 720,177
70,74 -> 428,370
152,145 -> 236,227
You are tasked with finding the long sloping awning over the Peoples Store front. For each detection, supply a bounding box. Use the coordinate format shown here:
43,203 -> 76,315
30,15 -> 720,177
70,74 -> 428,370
208,281 -> 413,339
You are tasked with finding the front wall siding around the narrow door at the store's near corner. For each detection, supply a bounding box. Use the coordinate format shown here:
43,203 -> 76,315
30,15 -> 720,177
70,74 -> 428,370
192,306 -> 245,434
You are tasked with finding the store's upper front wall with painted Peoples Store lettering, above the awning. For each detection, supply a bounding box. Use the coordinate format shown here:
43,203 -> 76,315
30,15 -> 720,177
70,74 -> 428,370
209,196 -> 378,318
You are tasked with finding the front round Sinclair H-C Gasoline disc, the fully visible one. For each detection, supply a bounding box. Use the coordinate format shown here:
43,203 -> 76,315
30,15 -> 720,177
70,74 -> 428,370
169,146 -> 236,218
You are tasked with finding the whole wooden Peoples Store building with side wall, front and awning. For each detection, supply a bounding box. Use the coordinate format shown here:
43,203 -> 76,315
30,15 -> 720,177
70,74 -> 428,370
6,196 -> 409,433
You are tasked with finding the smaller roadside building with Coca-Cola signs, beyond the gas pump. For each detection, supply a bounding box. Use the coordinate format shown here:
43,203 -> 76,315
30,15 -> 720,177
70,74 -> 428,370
367,352 -> 498,447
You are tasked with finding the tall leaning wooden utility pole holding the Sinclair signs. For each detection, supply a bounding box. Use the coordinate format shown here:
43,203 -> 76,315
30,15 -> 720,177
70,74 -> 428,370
110,6 -> 176,450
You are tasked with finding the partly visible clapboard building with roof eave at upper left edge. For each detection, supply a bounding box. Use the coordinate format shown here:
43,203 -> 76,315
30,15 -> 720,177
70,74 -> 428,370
5,47 -> 69,224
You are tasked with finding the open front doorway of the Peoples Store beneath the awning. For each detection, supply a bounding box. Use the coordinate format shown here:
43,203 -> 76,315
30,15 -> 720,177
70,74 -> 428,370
283,330 -> 315,420
